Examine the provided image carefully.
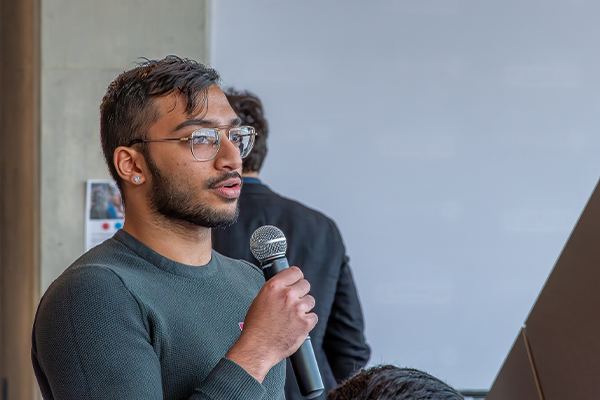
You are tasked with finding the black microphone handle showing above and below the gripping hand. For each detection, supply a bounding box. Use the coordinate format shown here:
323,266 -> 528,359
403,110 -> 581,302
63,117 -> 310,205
261,257 -> 325,399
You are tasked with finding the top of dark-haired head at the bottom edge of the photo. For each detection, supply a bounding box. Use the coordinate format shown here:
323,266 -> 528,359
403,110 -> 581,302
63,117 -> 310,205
327,365 -> 464,400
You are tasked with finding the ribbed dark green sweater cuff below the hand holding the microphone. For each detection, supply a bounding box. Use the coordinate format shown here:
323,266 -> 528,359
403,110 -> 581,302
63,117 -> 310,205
200,357 -> 266,400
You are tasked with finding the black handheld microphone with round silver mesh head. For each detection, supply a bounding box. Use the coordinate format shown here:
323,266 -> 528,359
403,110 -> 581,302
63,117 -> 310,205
250,225 -> 325,399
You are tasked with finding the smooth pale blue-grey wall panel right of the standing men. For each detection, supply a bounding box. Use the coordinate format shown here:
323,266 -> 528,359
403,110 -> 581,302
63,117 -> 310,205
211,0 -> 600,388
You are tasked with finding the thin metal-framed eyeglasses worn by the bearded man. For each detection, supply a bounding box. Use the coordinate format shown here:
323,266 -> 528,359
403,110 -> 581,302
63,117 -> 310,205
127,126 -> 256,161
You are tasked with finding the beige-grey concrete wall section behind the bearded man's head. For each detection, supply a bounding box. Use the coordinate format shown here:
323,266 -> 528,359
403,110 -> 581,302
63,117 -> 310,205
41,0 -> 208,291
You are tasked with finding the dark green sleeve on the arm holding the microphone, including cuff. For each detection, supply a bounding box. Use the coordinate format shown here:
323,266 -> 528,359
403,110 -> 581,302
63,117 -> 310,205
32,266 -> 265,400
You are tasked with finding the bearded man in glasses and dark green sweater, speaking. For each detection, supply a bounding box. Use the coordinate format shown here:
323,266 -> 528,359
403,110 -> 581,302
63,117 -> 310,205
32,56 -> 317,400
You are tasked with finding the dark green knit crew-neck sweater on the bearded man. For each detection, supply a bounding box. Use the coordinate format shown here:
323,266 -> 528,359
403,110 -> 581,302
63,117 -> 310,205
32,230 -> 285,400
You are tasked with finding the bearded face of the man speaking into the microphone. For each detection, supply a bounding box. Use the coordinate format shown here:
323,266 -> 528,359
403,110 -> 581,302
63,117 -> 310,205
145,85 -> 242,228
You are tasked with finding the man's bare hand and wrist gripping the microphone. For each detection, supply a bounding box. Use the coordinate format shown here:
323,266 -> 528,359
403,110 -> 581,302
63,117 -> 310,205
226,267 -> 318,383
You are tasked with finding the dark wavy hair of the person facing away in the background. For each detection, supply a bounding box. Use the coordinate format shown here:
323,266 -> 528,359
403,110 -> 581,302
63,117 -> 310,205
225,88 -> 269,172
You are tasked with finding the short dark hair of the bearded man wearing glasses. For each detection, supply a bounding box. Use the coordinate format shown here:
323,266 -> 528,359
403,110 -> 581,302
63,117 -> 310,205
100,56 -> 220,202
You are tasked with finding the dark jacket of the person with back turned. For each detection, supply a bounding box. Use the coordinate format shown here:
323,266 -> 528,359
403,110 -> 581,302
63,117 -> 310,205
213,183 -> 371,400
